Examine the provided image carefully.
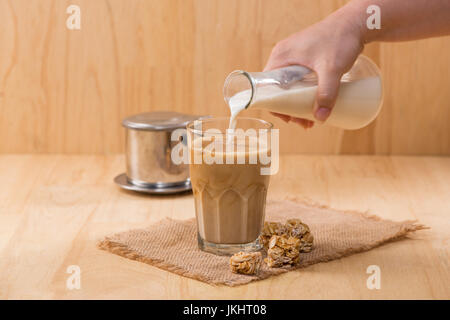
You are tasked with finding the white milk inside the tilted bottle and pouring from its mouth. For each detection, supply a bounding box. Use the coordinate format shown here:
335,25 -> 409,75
228,77 -> 382,129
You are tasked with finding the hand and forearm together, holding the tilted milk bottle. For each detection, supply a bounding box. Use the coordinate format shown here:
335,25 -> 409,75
264,0 -> 450,128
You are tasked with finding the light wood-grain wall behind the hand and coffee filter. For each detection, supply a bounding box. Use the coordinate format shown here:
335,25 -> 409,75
0,0 -> 450,155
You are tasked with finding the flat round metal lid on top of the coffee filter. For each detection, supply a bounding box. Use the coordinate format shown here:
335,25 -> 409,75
122,111 -> 201,131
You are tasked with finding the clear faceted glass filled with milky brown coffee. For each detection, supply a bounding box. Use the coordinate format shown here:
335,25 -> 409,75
187,118 -> 273,255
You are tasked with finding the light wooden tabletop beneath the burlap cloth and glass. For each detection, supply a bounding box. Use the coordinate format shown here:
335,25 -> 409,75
0,155 -> 450,299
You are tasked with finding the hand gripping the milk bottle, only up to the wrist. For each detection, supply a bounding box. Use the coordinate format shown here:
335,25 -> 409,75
264,10 -> 364,129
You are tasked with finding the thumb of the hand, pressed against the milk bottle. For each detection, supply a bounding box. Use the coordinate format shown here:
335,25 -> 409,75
313,72 -> 341,122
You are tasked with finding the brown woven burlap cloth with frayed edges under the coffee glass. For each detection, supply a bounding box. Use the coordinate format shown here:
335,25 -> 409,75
98,199 -> 426,286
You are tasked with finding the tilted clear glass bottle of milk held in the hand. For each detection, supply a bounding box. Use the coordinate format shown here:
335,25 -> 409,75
223,55 -> 383,130
